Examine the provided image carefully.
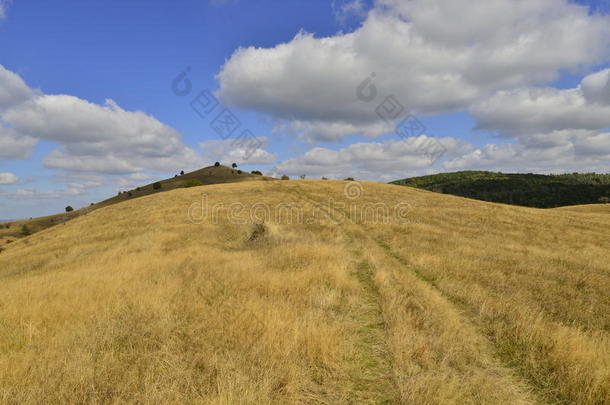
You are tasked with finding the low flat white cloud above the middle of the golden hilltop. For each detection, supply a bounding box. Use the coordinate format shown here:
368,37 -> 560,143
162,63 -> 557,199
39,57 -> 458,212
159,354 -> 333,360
272,135 -> 473,181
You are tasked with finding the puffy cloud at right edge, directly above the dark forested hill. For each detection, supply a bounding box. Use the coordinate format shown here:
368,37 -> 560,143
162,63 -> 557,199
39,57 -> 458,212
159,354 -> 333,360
466,69 -> 610,171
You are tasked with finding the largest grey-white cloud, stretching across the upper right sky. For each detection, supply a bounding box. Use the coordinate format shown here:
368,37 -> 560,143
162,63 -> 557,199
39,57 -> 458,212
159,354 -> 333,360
217,0 -> 610,139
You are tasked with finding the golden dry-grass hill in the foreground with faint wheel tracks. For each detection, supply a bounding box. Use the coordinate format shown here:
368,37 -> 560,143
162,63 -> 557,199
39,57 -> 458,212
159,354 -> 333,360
0,181 -> 610,404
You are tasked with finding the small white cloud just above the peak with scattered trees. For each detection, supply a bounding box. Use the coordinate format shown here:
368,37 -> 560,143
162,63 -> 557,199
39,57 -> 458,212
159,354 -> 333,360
199,137 -> 276,166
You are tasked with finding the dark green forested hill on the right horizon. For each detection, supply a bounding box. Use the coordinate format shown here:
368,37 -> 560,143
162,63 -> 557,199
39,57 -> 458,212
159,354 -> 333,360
391,171 -> 610,208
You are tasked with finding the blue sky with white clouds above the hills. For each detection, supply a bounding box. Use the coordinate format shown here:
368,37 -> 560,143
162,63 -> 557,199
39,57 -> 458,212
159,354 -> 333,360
0,0 -> 610,219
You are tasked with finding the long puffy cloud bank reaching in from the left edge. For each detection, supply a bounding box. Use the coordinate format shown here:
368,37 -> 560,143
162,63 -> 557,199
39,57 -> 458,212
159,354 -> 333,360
0,66 -> 200,174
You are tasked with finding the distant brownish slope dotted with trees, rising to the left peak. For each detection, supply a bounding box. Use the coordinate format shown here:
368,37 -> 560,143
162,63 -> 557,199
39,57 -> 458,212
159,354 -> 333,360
0,166 -> 275,244
